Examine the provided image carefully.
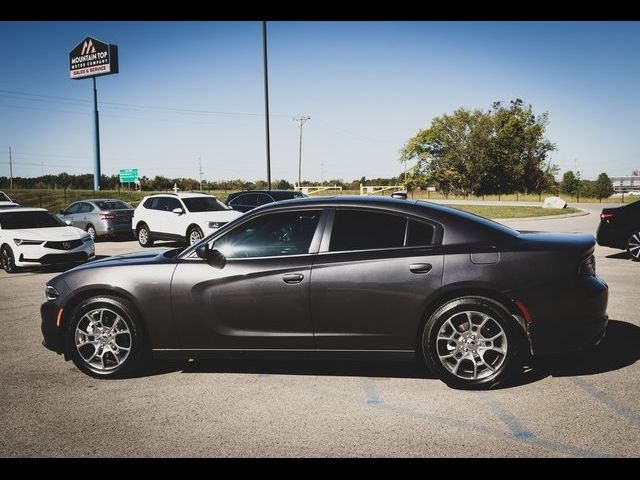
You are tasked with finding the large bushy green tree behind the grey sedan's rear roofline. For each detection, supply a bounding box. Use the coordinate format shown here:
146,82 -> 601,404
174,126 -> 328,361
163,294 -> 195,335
400,99 -> 556,195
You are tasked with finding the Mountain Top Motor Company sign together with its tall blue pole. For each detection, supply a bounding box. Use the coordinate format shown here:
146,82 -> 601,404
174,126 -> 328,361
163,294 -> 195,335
69,37 -> 118,190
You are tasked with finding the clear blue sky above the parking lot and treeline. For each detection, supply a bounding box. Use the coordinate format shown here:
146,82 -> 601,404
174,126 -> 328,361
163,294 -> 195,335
0,21 -> 640,183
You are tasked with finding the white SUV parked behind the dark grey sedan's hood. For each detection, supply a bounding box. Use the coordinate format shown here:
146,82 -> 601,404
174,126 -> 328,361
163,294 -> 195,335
131,193 -> 242,247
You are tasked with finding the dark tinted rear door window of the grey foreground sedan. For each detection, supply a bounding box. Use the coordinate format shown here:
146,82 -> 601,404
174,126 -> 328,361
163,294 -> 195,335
329,210 -> 407,252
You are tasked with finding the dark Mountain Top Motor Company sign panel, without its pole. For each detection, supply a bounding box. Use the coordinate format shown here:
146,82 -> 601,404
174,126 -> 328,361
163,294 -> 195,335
69,37 -> 118,80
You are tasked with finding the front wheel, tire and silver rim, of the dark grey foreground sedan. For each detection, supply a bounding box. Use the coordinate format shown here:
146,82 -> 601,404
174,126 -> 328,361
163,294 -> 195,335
65,296 -> 148,378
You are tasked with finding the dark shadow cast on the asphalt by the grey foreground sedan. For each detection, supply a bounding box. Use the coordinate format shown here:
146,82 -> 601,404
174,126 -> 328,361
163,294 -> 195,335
141,320 -> 640,389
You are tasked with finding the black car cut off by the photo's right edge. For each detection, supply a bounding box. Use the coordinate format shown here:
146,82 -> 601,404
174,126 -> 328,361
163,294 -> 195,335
597,201 -> 640,261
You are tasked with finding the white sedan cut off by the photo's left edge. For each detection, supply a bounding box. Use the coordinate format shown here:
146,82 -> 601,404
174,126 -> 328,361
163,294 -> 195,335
0,207 -> 95,273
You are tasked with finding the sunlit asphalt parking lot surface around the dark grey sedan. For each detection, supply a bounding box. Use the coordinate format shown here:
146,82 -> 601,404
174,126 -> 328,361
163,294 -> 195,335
0,204 -> 640,457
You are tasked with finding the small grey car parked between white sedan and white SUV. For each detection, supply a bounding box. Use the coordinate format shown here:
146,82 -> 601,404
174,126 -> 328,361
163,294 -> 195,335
58,198 -> 133,240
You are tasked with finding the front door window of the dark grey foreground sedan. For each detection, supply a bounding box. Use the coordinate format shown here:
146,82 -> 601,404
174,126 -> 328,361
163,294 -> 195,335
213,210 -> 321,258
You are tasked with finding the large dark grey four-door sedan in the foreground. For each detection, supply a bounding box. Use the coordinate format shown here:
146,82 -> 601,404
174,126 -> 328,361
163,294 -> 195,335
41,197 -> 608,388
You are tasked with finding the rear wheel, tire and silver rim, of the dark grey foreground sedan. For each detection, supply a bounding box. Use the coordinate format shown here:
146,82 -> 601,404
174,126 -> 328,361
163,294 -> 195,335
420,297 -> 523,389
